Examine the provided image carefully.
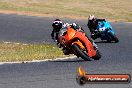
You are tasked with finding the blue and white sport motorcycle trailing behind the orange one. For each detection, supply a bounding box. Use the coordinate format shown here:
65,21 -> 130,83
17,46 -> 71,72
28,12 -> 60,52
92,21 -> 119,43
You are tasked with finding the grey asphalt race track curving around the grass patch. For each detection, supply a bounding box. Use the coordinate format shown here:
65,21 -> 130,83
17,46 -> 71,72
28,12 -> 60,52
0,14 -> 132,88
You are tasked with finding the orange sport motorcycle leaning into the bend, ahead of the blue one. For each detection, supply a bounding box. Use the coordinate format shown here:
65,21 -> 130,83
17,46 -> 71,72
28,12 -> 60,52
59,26 -> 101,61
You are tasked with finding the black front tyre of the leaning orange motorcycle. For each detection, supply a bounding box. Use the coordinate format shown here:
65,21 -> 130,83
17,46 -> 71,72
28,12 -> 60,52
72,44 -> 91,61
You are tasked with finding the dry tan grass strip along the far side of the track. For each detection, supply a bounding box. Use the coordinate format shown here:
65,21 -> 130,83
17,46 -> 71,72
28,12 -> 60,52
0,0 -> 132,21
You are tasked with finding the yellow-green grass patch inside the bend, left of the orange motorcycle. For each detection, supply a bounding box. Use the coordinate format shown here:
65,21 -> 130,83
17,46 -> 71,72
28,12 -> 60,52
0,43 -> 64,62
